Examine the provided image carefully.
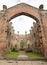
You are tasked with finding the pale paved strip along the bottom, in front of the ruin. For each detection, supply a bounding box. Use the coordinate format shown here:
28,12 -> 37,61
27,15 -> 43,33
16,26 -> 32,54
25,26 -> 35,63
0,60 -> 47,65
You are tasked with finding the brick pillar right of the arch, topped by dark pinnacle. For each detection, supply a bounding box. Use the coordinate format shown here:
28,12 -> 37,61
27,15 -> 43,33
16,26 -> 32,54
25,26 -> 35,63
39,5 -> 47,58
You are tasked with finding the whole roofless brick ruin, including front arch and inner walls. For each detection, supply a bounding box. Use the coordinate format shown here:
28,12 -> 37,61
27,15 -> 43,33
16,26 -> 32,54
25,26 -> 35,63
0,3 -> 47,58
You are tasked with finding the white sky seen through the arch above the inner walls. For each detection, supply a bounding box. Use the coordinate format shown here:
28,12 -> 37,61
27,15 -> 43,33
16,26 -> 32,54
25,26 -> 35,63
10,15 -> 36,35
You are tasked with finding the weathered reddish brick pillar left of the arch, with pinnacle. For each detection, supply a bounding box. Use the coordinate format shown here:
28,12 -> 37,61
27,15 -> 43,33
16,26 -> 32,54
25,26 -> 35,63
0,5 -> 7,54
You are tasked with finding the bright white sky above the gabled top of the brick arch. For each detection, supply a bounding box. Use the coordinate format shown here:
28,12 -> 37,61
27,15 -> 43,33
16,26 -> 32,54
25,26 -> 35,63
0,0 -> 47,10
